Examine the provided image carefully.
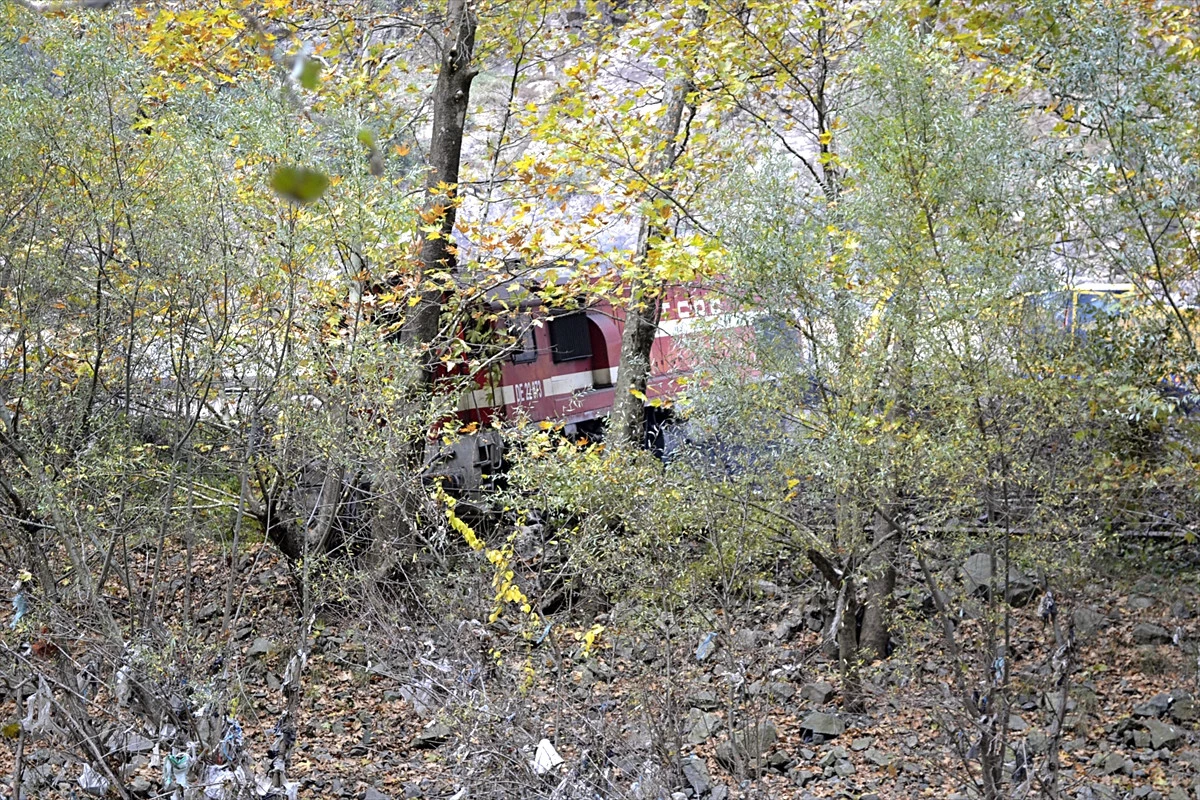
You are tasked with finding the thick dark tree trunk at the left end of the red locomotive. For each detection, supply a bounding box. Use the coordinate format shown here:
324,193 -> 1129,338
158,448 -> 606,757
402,0 -> 478,387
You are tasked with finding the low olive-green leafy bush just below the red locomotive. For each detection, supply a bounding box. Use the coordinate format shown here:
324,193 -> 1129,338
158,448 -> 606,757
501,432 -> 767,609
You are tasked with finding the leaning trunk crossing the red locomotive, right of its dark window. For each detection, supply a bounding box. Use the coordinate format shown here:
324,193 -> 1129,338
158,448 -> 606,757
608,7 -> 707,447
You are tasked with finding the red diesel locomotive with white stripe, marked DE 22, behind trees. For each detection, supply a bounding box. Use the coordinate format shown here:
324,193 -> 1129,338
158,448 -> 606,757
430,281 -> 739,492
